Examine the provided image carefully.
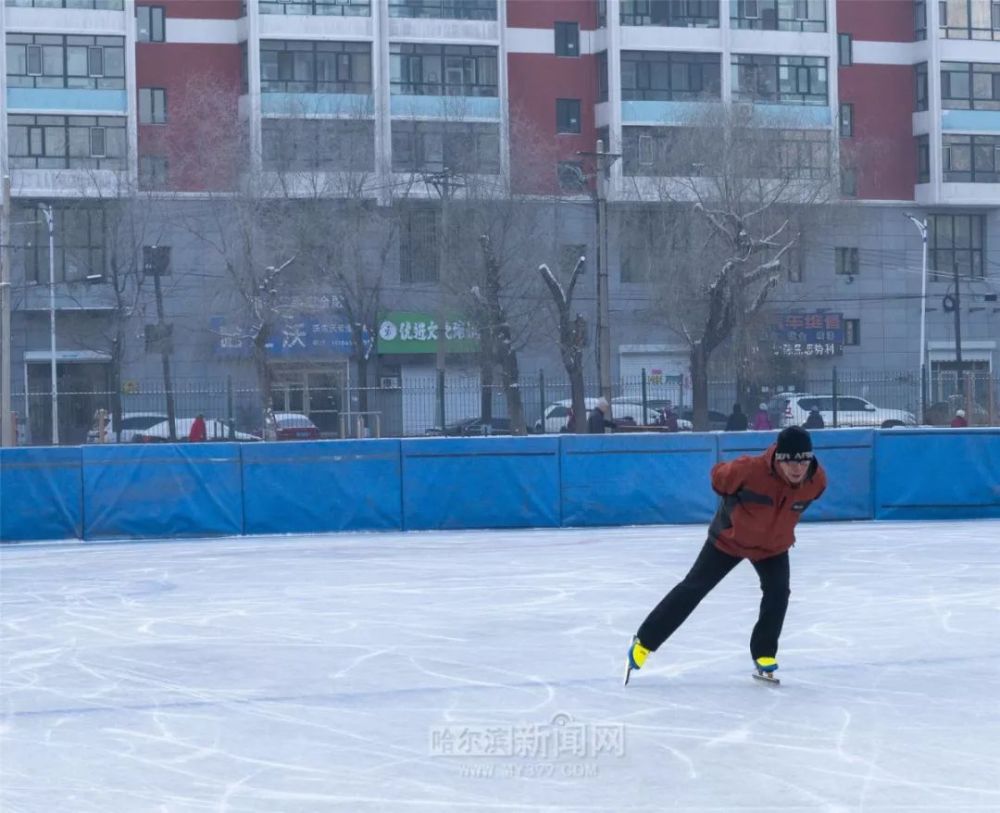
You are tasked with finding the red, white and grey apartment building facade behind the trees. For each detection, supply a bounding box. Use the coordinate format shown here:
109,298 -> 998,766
0,0 -> 1000,442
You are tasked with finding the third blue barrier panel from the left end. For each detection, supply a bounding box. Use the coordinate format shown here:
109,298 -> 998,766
243,440 -> 403,534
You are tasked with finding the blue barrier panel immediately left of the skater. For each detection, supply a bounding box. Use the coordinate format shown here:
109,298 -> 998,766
561,433 -> 717,526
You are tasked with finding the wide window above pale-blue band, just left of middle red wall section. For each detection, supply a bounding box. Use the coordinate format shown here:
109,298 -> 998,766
389,42 -> 497,96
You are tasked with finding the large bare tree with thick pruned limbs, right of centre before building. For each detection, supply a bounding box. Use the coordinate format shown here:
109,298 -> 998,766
624,105 -> 836,429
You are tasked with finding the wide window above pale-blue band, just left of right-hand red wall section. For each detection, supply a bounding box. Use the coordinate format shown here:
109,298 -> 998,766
732,54 -> 827,105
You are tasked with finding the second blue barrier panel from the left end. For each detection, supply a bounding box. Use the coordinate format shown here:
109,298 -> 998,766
83,443 -> 243,539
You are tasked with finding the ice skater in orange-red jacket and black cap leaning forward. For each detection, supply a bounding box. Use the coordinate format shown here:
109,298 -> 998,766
625,426 -> 826,686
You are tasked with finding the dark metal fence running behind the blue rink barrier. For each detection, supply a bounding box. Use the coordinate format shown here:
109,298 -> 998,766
12,370 -> 1000,445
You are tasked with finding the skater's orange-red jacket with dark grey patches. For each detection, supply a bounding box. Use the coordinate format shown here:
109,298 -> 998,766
708,444 -> 826,562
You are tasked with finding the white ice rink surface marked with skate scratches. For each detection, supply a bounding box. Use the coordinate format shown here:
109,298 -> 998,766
0,521 -> 1000,813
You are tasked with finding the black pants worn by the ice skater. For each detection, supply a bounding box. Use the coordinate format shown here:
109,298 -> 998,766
638,541 -> 790,658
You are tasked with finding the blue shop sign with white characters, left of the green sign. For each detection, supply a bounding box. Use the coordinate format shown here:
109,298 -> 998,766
209,313 -> 353,358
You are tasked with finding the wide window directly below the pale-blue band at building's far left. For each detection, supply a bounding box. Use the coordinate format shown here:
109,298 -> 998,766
7,113 -> 128,170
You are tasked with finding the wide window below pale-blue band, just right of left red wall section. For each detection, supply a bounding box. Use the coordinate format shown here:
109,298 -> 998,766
261,118 -> 375,172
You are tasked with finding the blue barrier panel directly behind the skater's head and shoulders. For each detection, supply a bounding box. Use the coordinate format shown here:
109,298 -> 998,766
719,429 -> 876,522
